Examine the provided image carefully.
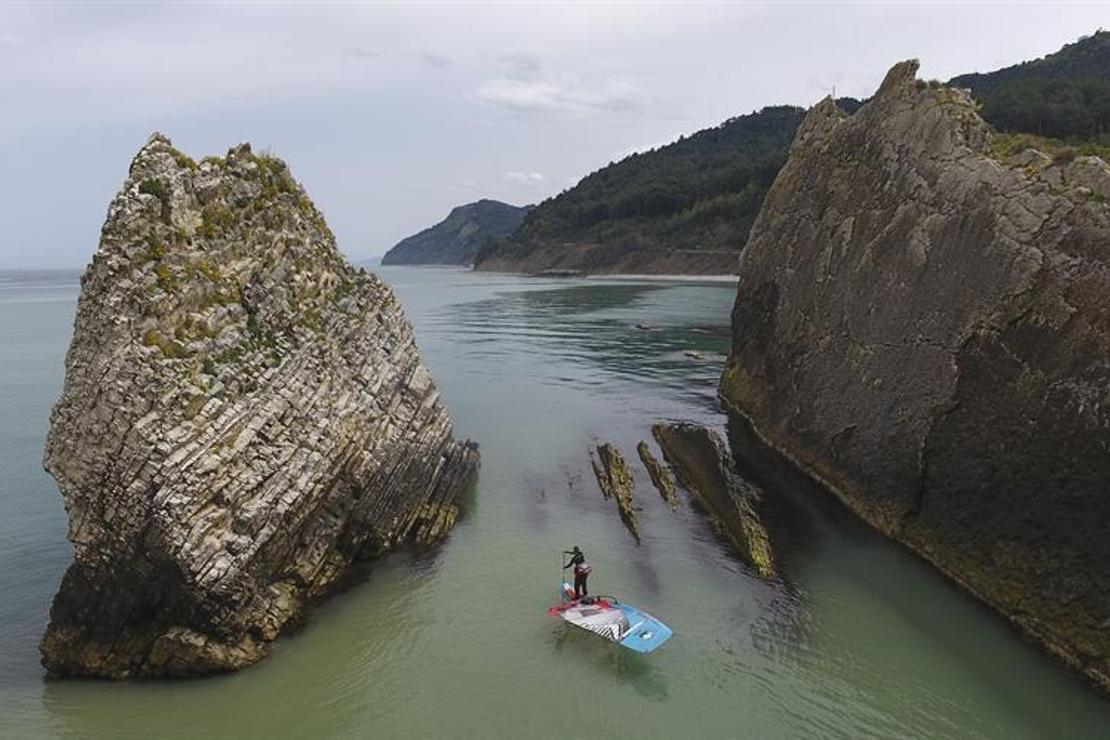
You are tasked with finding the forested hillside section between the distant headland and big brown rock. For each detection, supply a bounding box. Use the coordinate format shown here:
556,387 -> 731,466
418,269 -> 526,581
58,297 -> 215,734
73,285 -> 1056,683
475,105 -> 852,272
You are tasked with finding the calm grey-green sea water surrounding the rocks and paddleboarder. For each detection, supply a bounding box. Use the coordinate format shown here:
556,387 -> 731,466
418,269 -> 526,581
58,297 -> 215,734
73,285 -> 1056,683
0,267 -> 1110,738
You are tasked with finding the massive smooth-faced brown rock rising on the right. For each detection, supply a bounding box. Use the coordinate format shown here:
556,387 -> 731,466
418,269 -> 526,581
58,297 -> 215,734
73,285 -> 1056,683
720,62 -> 1110,688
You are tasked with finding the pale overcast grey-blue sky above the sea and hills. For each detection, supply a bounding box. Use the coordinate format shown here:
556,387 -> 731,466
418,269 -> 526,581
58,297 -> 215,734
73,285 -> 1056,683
0,0 -> 1110,268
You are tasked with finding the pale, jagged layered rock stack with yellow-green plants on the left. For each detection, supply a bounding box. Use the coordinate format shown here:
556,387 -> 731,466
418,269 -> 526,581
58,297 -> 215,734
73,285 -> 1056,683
41,134 -> 477,678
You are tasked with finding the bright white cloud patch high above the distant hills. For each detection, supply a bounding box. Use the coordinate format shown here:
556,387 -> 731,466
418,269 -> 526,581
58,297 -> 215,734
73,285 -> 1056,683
476,78 -> 647,113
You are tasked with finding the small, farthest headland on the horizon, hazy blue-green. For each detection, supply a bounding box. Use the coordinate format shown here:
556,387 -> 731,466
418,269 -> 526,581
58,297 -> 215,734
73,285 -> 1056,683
382,200 -> 532,265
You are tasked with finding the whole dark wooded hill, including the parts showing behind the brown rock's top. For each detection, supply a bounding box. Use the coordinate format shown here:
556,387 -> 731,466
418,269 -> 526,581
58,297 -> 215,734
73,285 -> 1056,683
475,31 -> 1110,273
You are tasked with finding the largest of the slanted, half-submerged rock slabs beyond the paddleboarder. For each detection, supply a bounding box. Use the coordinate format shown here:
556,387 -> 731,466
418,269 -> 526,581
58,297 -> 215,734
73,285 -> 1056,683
652,424 -> 775,578
